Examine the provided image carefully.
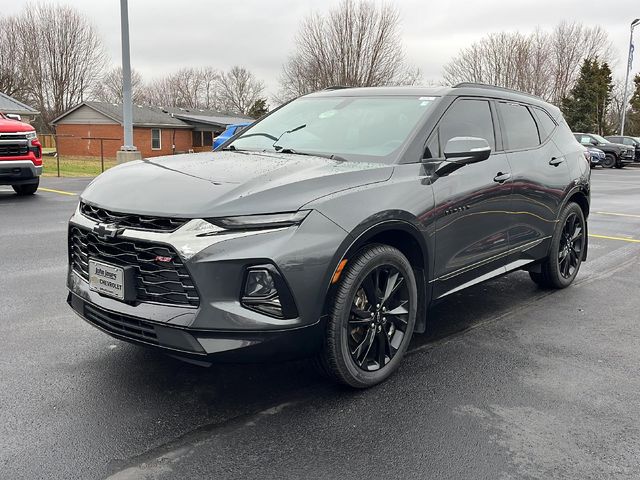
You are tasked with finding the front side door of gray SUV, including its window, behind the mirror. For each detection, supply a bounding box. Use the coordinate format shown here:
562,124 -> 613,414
428,98 -> 511,298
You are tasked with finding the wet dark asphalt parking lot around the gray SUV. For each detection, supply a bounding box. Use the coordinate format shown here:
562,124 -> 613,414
0,168 -> 640,479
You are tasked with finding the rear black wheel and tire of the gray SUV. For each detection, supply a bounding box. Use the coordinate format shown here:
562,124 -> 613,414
529,202 -> 587,289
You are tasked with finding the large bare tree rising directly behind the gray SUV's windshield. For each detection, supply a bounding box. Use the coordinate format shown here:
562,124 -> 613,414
278,0 -> 420,101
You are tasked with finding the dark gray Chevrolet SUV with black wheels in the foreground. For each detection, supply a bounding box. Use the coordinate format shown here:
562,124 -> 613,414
67,84 -> 590,388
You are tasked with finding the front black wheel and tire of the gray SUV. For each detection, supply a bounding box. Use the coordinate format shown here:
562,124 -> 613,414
317,245 -> 418,388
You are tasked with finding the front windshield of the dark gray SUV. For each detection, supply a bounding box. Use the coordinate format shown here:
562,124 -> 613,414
227,96 -> 435,163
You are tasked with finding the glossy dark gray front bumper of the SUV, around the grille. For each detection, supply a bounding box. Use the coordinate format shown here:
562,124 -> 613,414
67,204 -> 347,361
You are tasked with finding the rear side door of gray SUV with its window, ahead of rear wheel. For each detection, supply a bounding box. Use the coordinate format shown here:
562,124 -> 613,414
496,101 -> 569,258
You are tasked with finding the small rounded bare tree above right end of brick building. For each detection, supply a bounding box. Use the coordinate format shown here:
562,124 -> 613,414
218,66 -> 264,115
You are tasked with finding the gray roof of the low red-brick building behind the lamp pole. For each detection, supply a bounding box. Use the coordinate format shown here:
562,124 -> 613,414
51,101 -> 250,128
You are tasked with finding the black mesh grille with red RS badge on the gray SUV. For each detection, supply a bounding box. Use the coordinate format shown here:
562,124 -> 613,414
69,226 -> 200,307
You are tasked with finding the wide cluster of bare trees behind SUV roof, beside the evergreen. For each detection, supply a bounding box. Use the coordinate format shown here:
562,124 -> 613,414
443,22 -> 613,104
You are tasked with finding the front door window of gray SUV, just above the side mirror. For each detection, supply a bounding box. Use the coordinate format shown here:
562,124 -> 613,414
427,99 -> 496,156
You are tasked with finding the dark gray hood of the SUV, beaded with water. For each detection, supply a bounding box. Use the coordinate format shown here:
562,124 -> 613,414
81,151 -> 393,218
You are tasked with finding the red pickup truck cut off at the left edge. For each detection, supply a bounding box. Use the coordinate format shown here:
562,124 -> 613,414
0,113 -> 42,195
